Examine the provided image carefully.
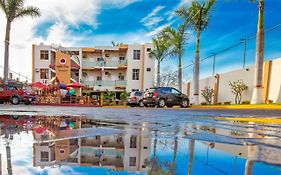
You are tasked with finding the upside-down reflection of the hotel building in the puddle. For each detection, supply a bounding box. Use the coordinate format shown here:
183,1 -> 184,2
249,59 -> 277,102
30,117 -> 151,172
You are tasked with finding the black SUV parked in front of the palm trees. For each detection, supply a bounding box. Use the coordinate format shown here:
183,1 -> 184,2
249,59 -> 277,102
143,87 -> 189,108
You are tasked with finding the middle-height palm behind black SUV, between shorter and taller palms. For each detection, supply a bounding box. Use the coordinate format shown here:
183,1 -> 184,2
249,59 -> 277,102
160,23 -> 188,91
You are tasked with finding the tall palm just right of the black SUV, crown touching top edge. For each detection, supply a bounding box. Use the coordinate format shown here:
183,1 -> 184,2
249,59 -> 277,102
176,0 -> 216,104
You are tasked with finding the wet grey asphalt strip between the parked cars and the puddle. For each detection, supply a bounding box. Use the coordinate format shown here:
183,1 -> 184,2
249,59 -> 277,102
0,105 -> 281,117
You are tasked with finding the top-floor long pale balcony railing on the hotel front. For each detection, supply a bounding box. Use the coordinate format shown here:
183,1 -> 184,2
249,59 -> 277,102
82,60 -> 127,68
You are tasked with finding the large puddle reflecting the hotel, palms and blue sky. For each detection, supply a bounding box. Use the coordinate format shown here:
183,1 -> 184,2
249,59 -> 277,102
0,116 -> 281,175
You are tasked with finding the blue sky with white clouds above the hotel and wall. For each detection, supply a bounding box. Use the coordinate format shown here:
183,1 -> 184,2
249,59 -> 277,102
0,0 -> 281,80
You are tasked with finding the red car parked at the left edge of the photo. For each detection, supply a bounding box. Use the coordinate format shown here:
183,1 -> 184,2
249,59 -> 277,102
0,84 -> 35,105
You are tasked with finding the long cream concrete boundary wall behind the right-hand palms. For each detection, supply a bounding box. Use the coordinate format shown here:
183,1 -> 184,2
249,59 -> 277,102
187,58 -> 281,103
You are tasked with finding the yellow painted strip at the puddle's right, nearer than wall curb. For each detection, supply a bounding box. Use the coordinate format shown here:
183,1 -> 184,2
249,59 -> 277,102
216,117 -> 281,124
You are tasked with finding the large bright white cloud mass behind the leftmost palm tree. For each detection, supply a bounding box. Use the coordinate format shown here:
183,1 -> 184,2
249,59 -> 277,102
0,0 -> 139,80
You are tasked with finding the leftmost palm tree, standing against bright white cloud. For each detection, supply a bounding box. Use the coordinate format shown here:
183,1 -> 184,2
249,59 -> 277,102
0,0 -> 40,82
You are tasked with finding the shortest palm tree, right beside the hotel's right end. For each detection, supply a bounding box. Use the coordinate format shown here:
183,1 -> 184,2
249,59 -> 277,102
149,37 -> 169,87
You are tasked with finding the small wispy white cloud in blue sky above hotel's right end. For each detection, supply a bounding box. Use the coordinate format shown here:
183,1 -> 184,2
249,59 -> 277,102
140,5 -> 165,29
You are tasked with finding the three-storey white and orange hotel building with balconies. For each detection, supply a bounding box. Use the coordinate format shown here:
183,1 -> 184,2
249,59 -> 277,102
32,43 -> 155,96
